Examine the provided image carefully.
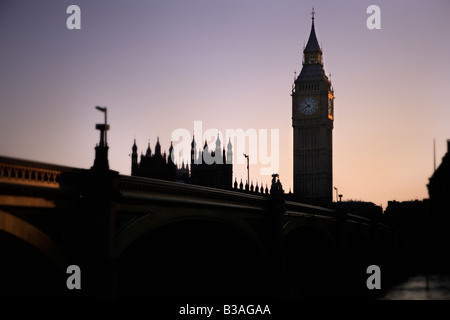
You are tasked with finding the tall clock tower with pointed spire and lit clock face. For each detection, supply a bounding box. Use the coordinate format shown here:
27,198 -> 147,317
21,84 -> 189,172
292,9 -> 334,206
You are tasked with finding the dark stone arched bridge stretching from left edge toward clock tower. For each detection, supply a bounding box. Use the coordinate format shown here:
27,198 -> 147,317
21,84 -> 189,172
0,157 -> 393,299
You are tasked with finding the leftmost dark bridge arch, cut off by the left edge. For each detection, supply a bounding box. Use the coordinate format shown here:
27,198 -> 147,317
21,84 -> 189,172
0,210 -> 66,298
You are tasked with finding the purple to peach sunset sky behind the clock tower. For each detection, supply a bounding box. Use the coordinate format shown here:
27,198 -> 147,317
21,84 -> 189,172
0,0 -> 450,208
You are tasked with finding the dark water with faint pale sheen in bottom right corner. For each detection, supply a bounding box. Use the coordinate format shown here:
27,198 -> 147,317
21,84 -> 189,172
381,274 -> 450,300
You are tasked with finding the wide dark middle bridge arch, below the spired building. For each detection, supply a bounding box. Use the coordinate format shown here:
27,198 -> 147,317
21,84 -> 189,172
115,213 -> 266,298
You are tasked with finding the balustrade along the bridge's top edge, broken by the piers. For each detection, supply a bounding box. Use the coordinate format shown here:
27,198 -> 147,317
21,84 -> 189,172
0,156 -> 390,229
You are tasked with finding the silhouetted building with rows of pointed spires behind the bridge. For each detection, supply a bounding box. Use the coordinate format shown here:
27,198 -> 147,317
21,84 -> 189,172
131,137 -> 233,189
